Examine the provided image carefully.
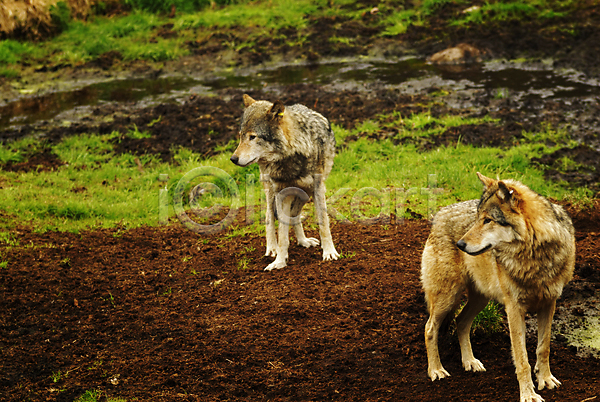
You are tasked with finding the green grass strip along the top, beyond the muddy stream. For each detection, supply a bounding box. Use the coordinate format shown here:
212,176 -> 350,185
0,0 -> 579,69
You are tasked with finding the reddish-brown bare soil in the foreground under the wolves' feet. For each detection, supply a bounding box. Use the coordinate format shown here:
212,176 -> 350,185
0,206 -> 600,402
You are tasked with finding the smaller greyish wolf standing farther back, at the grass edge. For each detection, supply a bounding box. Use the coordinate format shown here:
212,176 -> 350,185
231,94 -> 339,271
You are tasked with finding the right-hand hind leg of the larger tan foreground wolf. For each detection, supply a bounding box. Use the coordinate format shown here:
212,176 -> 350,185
456,287 -> 489,371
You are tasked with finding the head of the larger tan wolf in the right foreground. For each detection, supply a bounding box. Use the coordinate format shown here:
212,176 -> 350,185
456,172 -> 531,255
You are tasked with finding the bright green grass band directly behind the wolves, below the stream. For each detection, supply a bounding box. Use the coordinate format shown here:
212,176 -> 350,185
0,107 -> 592,236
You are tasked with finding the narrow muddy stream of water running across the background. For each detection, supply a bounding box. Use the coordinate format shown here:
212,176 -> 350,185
0,58 -> 600,130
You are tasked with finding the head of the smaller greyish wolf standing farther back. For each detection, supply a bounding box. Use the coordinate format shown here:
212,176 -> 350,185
231,94 -> 285,166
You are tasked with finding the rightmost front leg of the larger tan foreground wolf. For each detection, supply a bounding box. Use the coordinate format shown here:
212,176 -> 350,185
534,300 -> 560,390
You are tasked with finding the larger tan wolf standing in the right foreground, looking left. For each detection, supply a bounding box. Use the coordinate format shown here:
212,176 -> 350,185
421,173 -> 575,402
